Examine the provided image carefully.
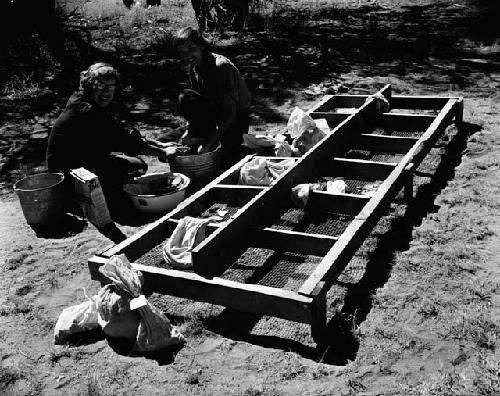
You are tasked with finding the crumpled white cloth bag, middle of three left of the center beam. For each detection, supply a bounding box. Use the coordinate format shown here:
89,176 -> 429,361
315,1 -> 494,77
238,158 -> 295,186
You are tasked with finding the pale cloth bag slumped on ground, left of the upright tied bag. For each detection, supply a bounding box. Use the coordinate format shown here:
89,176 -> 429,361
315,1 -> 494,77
54,291 -> 99,345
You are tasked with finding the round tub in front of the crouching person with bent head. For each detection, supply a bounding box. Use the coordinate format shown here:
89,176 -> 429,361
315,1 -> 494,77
168,146 -> 221,188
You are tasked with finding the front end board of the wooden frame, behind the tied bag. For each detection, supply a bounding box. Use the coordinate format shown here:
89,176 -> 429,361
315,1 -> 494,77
89,256 -> 312,323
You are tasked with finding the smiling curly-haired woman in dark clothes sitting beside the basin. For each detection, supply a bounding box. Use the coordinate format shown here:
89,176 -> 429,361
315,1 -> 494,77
47,63 -> 166,210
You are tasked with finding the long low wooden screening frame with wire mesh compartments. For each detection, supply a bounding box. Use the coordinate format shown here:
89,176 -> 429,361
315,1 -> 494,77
88,85 -> 463,342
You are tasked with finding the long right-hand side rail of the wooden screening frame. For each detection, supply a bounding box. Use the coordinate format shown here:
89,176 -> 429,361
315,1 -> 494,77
299,99 -> 458,295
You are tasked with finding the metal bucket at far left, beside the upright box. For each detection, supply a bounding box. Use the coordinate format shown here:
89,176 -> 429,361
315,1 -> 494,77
14,173 -> 66,227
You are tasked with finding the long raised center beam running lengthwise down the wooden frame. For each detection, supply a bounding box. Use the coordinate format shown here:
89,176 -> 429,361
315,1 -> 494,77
192,93 -> 382,278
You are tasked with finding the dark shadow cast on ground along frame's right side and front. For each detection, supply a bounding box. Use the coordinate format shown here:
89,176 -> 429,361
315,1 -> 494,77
197,123 -> 481,365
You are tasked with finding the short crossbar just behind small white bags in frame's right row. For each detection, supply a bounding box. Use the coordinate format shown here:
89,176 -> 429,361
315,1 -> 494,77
328,157 -> 398,181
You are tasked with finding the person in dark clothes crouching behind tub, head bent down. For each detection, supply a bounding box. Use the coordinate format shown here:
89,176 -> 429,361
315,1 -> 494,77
174,27 -> 250,167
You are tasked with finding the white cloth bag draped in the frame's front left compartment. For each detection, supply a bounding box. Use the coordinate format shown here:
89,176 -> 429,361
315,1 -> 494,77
163,216 -> 212,270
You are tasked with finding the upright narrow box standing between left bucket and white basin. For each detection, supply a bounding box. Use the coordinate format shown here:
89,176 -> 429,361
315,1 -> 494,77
70,168 -> 113,228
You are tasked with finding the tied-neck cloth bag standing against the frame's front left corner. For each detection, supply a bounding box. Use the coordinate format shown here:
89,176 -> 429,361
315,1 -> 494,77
97,255 -> 184,352
